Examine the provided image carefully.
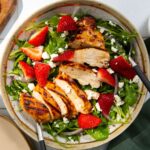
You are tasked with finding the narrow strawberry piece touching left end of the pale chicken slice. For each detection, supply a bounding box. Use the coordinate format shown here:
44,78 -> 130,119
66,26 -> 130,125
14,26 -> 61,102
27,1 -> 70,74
53,50 -> 74,62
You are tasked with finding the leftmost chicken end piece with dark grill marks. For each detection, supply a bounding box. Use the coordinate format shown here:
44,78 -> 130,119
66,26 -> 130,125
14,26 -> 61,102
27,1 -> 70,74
20,93 -> 51,123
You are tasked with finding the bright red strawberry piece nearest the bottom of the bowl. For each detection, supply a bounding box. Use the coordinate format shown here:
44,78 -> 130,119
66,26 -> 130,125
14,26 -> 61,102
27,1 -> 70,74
78,114 -> 102,129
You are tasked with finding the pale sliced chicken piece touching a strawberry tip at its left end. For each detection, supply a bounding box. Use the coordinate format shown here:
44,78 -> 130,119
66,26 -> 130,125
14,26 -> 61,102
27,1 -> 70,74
70,48 -> 110,68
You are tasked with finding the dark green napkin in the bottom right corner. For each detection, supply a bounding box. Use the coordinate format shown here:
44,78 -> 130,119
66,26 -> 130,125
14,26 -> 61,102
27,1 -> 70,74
108,100 -> 150,150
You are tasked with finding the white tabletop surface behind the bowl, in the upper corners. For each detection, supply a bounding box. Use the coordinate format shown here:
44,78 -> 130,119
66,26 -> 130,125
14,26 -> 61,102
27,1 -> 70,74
0,0 -> 150,150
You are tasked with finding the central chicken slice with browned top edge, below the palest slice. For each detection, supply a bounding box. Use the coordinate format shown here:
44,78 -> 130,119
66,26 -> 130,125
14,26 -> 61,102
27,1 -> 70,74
59,63 -> 101,88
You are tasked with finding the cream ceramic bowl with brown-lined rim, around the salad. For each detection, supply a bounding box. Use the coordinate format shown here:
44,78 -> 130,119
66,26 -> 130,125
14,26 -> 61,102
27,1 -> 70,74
0,0 -> 150,150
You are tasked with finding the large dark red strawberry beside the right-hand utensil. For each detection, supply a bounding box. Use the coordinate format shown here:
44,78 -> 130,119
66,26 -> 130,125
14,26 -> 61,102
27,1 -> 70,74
110,56 -> 136,79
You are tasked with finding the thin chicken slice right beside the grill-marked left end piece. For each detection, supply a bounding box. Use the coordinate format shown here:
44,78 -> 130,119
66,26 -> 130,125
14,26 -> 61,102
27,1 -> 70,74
32,90 -> 61,121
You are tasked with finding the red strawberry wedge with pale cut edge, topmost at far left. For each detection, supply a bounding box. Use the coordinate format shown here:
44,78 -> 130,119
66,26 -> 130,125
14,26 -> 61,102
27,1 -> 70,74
28,26 -> 48,46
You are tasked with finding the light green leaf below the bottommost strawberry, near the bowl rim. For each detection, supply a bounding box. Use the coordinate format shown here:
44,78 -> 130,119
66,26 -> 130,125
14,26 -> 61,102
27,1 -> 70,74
85,126 -> 109,141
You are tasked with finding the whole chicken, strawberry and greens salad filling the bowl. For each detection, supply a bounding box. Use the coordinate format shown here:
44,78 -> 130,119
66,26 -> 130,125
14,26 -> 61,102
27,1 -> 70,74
6,14 -> 140,142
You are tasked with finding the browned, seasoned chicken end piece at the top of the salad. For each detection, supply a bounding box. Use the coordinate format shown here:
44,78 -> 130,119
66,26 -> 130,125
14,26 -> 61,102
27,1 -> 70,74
69,17 -> 105,50
